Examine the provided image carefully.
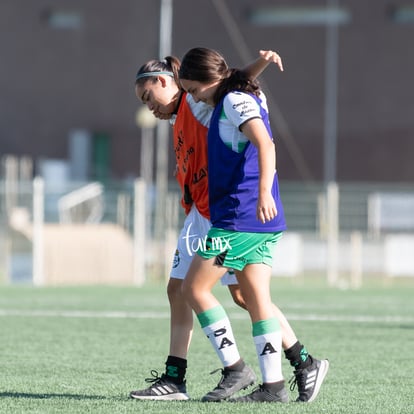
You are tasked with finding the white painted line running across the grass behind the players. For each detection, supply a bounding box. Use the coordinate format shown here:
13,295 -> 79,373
0,309 -> 414,323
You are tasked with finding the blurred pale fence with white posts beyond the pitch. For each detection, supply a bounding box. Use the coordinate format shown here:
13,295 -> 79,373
0,157 -> 414,288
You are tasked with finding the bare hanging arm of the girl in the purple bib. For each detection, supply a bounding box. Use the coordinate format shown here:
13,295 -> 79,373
242,118 -> 277,223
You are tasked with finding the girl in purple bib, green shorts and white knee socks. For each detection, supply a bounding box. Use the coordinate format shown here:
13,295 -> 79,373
179,48 -> 329,402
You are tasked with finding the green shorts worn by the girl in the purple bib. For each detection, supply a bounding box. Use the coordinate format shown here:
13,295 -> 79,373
197,227 -> 283,270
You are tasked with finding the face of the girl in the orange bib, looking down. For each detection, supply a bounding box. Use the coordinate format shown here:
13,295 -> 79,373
135,75 -> 180,117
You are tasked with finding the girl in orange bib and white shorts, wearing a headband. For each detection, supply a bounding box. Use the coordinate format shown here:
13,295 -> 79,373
131,51 -> 328,400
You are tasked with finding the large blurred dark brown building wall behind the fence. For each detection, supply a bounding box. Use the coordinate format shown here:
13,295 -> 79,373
0,0 -> 414,181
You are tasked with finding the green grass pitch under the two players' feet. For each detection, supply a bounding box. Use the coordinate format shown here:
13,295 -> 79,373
0,279 -> 414,414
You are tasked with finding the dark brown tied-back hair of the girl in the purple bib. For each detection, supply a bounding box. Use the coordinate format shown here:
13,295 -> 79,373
178,47 -> 259,105
